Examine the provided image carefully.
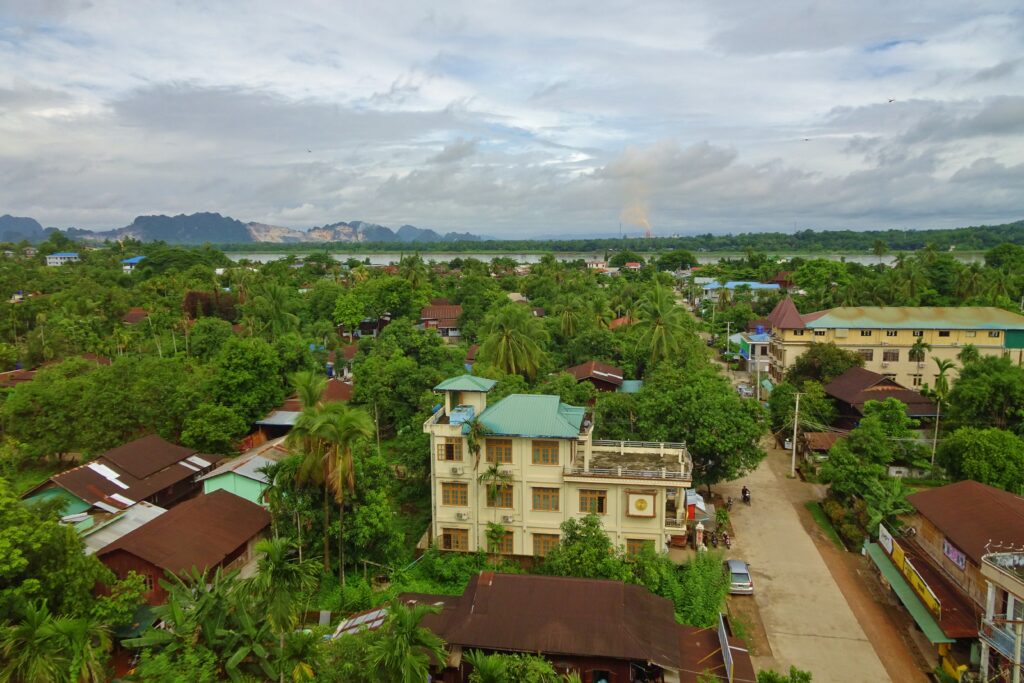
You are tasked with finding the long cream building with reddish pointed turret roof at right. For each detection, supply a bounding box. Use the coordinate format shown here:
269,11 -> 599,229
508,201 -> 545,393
768,298 -> 1024,387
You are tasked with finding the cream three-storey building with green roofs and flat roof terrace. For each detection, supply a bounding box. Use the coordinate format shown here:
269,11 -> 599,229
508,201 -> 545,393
423,375 -> 692,556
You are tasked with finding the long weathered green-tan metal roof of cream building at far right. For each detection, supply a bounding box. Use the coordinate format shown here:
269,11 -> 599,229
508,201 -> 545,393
803,306 -> 1024,330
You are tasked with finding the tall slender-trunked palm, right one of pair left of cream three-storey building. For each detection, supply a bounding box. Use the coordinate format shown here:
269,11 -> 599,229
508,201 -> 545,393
323,402 -> 374,586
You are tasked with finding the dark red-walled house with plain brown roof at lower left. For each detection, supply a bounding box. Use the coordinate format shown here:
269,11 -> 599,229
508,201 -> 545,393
96,490 -> 270,605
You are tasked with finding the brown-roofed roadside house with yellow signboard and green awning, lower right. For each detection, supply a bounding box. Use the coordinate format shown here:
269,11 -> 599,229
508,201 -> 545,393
867,480 -> 1024,680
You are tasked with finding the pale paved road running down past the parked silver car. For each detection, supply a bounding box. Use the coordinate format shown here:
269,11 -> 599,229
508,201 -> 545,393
719,451 -> 892,683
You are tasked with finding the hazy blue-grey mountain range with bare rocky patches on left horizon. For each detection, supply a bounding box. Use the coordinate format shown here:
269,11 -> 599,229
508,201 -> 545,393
0,213 -> 480,245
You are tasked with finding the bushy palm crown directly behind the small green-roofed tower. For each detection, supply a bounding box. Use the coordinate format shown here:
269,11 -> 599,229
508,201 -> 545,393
477,303 -> 548,379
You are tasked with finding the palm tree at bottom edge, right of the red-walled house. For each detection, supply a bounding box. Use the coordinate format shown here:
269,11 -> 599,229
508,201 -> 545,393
245,539 -> 318,683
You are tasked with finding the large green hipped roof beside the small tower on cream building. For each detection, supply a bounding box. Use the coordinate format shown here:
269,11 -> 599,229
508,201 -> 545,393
478,393 -> 586,438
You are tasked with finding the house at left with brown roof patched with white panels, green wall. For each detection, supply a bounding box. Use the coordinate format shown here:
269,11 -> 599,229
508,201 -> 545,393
23,434 -> 220,515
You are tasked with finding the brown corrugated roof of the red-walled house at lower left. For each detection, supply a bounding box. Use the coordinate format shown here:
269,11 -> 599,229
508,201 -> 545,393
96,489 -> 270,573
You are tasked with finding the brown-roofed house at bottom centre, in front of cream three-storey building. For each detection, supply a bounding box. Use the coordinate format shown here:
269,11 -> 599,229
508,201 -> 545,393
336,571 -> 755,683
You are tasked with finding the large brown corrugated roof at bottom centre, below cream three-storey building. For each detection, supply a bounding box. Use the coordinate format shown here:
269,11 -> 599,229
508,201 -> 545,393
402,571 -> 680,669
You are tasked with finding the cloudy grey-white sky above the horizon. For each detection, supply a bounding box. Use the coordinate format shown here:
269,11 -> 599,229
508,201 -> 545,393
0,0 -> 1024,237
